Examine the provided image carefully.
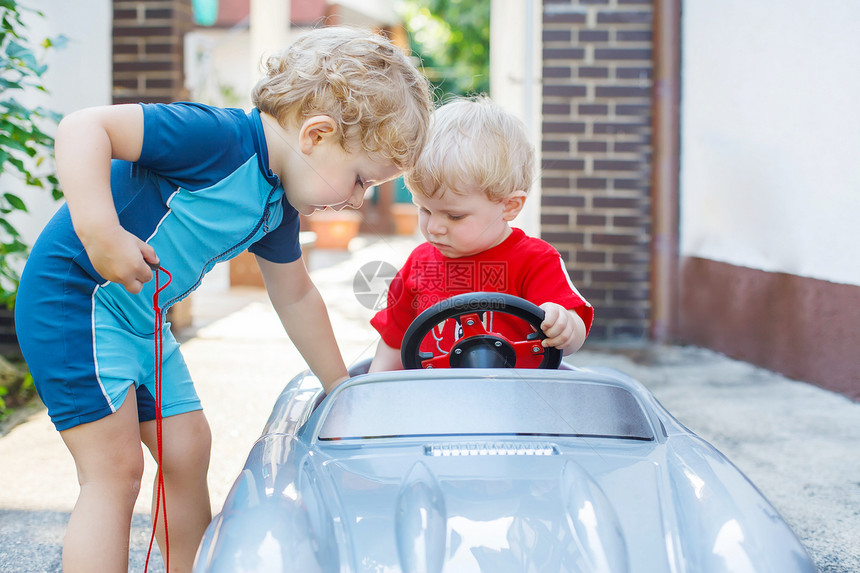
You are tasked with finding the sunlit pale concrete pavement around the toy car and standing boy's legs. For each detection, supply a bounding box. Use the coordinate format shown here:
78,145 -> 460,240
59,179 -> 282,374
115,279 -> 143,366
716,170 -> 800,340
0,237 -> 860,573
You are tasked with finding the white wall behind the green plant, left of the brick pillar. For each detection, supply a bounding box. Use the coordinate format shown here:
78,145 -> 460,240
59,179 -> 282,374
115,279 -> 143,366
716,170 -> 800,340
4,0 -> 112,244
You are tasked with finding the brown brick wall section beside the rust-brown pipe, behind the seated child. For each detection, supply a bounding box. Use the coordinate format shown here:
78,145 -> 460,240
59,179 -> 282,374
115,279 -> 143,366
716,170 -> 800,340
541,0 -> 652,341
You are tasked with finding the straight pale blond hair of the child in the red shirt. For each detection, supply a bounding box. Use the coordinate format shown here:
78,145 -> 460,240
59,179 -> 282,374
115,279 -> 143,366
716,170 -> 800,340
405,96 -> 535,201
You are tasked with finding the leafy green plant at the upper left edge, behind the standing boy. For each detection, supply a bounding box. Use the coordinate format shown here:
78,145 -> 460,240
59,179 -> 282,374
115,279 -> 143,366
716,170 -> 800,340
0,0 -> 65,308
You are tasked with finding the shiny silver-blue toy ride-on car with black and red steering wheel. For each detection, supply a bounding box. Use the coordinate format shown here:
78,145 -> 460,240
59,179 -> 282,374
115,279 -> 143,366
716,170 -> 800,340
194,293 -> 816,573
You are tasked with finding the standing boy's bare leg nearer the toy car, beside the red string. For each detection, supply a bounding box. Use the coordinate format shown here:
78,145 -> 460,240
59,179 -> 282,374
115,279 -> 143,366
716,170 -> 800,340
140,410 -> 212,573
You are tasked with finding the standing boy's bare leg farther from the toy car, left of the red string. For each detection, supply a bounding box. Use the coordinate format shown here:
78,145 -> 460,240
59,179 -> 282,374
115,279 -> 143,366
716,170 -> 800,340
60,384 -> 143,573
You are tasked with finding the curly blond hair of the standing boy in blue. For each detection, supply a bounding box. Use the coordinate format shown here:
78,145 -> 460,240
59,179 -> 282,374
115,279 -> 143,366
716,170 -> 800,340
251,26 -> 433,170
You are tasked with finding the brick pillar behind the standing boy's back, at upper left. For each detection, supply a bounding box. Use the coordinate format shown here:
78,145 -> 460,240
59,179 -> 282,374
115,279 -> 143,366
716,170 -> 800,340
113,0 -> 193,103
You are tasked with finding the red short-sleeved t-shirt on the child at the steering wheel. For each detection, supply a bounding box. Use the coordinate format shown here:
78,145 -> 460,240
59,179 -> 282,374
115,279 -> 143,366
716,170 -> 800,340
370,228 -> 594,367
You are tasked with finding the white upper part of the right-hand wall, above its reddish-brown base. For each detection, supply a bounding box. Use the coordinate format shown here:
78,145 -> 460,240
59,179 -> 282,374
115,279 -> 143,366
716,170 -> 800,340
680,0 -> 860,285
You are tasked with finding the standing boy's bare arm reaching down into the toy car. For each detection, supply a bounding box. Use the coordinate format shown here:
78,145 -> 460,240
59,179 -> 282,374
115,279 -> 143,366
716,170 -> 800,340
257,257 -> 348,393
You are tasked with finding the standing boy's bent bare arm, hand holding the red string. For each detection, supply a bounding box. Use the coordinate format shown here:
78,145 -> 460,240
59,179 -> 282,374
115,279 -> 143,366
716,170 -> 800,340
55,105 -> 158,293
